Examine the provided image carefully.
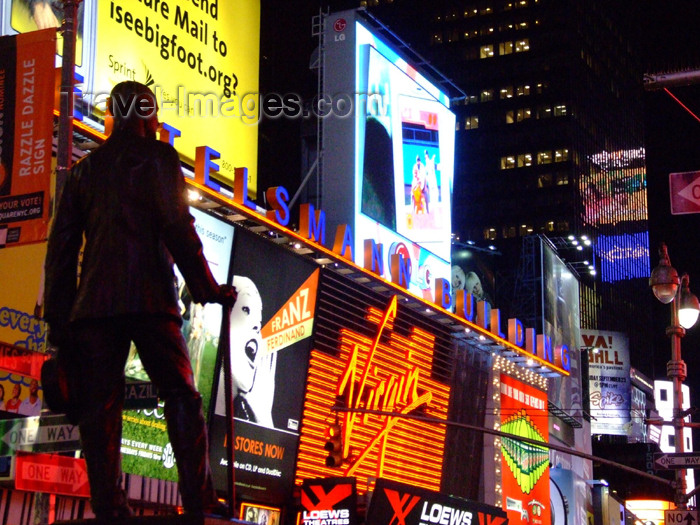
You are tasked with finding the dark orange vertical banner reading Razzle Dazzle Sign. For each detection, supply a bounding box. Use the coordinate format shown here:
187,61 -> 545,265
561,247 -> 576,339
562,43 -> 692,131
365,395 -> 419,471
0,29 -> 56,248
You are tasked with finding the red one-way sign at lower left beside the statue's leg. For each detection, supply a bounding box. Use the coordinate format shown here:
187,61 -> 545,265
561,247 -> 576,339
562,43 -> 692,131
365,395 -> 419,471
15,453 -> 90,498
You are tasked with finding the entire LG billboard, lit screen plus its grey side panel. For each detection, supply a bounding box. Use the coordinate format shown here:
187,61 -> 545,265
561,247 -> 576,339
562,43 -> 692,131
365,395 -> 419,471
323,11 -> 455,299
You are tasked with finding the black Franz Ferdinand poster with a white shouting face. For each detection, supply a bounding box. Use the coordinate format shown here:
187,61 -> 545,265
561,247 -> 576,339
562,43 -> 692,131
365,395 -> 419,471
211,229 -> 319,505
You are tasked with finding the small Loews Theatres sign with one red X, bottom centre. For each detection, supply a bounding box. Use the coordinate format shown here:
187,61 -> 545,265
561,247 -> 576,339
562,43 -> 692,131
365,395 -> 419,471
297,478 -> 358,525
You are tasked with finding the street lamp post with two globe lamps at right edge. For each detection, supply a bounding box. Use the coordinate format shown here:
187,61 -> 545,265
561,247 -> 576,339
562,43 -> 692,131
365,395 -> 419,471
649,243 -> 700,509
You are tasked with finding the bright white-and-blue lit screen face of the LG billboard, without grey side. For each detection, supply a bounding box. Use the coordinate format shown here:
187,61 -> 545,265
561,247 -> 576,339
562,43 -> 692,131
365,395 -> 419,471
355,23 -> 455,292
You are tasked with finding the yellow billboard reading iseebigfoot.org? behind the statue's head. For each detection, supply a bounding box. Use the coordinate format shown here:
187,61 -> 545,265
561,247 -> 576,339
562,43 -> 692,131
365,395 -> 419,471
88,0 -> 260,195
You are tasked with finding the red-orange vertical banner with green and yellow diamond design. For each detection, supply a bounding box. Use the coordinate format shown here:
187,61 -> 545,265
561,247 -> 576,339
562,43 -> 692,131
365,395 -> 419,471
501,374 -> 551,525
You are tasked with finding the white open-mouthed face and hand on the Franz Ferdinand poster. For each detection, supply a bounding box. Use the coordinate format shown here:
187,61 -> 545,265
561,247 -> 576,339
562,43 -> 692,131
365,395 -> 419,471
215,275 -> 277,428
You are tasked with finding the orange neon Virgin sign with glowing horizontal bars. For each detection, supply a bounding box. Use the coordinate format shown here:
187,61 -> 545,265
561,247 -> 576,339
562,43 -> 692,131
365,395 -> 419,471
296,297 -> 450,493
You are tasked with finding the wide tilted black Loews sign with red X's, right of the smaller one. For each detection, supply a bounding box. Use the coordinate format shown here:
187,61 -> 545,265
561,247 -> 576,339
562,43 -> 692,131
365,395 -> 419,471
366,478 -> 506,525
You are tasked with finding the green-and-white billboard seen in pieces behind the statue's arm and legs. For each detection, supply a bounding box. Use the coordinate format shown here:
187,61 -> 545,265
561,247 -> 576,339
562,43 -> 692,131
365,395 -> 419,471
121,208 -> 234,481
